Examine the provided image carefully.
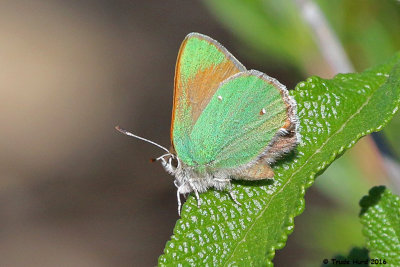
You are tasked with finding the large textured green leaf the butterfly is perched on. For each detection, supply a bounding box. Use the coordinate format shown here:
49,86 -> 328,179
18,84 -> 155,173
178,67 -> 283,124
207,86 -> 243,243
159,55 -> 400,266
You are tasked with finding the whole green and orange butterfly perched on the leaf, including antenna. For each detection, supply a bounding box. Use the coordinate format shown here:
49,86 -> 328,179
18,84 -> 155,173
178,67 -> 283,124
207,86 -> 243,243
116,33 -> 300,214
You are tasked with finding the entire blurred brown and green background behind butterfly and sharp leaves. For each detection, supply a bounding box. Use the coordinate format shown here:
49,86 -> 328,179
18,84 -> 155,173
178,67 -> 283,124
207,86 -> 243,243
0,0 -> 400,266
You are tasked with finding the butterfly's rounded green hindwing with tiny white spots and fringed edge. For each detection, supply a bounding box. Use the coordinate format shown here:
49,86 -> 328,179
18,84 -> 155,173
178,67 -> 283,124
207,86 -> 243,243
176,70 -> 297,179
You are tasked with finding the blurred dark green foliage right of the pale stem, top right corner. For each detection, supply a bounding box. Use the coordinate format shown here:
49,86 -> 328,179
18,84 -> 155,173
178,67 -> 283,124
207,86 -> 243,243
316,0 -> 400,70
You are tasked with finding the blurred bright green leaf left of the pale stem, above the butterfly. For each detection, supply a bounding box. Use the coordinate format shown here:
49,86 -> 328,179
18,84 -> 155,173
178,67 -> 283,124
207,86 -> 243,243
205,0 -> 319,70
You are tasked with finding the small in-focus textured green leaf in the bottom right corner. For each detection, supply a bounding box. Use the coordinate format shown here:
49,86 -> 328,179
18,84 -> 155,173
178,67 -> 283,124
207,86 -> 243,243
360,186 -> 400,266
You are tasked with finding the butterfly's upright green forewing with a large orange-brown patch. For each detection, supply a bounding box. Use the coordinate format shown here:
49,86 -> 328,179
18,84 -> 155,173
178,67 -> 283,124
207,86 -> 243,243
171,33 -> 246,152
